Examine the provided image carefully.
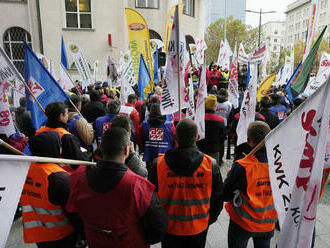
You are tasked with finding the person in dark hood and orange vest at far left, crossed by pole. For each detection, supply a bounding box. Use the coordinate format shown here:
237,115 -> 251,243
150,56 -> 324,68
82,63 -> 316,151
20,131 -> 82,248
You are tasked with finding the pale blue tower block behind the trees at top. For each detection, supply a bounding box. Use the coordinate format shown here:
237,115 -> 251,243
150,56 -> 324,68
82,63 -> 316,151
205,0 -> 246,28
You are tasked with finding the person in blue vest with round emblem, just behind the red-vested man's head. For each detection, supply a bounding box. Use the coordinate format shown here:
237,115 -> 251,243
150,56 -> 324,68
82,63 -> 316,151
95,99 -> 120,145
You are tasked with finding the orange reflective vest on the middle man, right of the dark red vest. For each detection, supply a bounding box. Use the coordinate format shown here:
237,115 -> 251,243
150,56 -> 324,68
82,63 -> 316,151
157,154 -> 212,235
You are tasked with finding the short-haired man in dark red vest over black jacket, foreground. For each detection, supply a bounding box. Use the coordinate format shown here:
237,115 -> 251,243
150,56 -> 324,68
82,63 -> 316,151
66,127 -> 167,248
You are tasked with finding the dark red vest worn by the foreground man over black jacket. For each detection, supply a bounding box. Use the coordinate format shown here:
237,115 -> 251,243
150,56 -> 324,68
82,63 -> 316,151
66,166 -> 155,248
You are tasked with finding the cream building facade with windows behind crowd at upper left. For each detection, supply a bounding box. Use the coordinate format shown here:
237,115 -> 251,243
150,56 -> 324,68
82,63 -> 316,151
0,0 -> 205,80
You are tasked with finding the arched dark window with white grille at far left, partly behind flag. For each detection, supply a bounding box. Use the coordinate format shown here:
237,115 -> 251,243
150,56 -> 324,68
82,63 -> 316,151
3,27 -> 32,75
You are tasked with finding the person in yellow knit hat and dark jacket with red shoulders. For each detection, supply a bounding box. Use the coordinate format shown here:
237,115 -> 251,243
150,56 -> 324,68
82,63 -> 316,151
197,95 -> 226,165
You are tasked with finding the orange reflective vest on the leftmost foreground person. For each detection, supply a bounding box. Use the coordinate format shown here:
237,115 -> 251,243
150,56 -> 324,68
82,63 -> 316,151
21,163 -> 74,243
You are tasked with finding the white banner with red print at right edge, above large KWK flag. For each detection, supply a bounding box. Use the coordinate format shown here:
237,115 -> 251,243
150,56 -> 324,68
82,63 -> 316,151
304,52 -> 330,95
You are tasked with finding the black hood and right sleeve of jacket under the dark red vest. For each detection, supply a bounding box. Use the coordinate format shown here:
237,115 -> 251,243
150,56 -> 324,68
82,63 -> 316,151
86,161 -> 167,244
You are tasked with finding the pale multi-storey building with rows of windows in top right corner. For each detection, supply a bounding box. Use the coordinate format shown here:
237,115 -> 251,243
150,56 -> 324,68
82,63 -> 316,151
285,0 -> 330,47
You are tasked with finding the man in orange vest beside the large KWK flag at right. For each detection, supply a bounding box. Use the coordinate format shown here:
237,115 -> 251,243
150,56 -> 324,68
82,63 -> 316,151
224,121 -> 277,248
